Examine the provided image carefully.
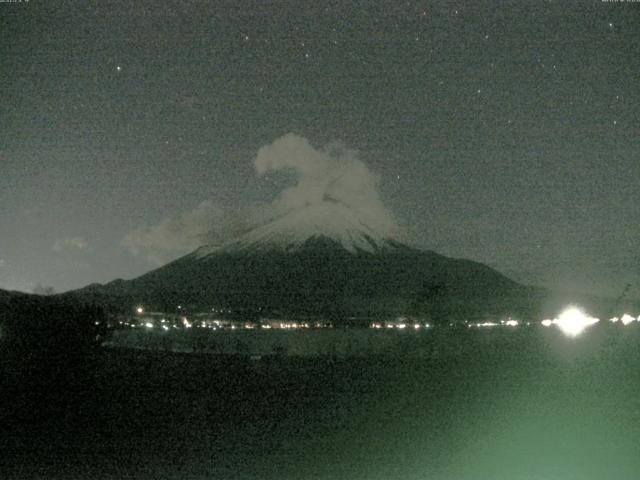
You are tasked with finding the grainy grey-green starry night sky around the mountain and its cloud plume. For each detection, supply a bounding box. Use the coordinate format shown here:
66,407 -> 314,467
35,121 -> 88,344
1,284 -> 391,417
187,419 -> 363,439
0,0 -> 640,297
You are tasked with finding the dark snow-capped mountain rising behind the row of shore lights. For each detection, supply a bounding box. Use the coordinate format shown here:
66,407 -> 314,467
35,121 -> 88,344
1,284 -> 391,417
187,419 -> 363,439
70,202 -> 552,321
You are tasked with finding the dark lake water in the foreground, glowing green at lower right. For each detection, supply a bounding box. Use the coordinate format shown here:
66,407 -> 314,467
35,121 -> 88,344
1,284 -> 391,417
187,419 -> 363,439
0,326 -> 640,480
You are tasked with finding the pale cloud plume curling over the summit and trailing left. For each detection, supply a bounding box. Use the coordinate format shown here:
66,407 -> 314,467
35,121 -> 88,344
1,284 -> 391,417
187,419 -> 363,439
122,133 -> 397,265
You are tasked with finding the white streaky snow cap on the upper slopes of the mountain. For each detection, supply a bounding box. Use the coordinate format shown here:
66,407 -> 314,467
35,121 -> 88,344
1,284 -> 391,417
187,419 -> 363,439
195,202 -> 398,258
